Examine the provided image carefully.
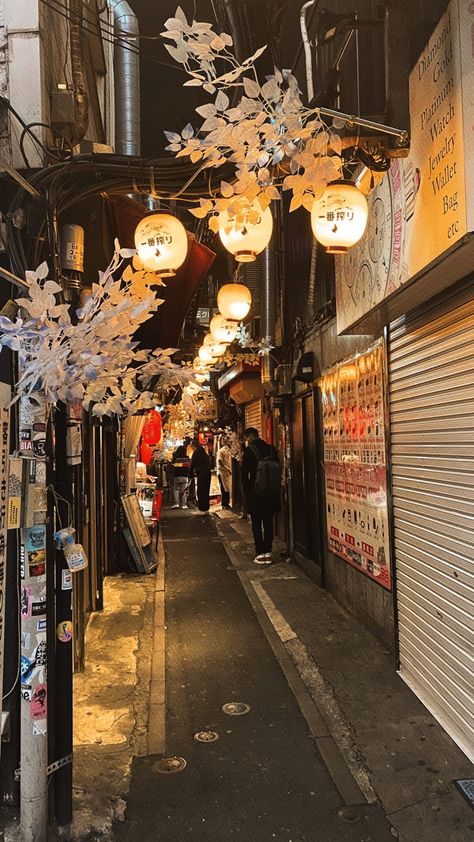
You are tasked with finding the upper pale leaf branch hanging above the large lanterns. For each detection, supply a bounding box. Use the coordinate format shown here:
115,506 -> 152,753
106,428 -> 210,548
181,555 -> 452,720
161,8 -> 342,226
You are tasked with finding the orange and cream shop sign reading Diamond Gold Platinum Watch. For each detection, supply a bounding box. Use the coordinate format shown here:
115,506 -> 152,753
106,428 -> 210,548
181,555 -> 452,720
336,0 -> 474,333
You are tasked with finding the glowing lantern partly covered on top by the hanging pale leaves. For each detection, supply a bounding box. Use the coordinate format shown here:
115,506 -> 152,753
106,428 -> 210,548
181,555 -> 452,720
219,202 -> 273,263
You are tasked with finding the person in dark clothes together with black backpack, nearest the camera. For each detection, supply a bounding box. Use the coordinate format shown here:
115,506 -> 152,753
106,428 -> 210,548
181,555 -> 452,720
242,427 -> 280,564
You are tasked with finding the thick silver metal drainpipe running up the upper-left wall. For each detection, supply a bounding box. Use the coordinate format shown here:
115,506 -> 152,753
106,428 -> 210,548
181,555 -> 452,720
110,0 -> 140,155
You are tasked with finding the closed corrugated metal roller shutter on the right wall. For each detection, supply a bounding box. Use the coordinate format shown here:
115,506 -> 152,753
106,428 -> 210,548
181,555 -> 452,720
389,292 -> 474,760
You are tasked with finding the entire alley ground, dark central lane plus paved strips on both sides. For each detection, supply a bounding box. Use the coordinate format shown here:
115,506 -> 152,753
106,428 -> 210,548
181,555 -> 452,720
5,510 -> 474,842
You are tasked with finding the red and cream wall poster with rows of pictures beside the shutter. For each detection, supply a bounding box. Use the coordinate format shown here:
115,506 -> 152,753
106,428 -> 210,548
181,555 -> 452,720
320,343 -> 392,590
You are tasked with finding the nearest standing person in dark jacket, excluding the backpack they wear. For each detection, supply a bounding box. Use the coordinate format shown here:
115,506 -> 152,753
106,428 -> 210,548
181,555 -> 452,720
242,427 -> 280,564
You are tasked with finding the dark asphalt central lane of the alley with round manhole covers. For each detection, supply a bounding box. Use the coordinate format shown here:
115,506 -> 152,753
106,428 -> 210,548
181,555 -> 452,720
114,510 -> 418,842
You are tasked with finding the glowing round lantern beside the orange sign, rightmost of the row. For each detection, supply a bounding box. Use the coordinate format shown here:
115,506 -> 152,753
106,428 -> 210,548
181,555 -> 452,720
311,179 -> 369,254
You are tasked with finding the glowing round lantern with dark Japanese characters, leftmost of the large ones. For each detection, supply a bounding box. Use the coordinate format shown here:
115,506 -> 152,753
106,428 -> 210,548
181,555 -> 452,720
135,213 -> 188,278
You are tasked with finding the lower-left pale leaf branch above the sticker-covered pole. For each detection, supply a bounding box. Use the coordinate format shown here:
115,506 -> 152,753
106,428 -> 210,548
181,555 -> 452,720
0,240 -> 200,416
